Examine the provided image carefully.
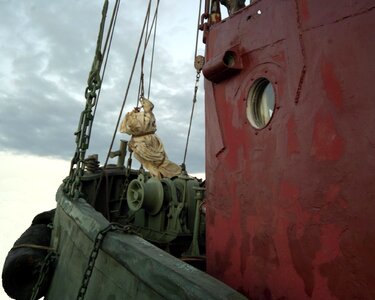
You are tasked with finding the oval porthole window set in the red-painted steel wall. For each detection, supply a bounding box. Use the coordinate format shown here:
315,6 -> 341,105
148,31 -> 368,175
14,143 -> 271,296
246,78 -> 275,129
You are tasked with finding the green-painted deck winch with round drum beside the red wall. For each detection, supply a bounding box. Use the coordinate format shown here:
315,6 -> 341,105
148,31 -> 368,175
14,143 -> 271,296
127,174 -> 201,243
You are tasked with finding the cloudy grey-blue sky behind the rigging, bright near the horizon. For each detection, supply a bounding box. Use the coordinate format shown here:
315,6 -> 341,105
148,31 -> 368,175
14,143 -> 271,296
0,0 -> 204,299
